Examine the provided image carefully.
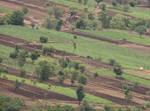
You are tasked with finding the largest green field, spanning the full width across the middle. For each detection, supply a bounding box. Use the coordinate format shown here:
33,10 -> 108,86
0,26 -> 150,69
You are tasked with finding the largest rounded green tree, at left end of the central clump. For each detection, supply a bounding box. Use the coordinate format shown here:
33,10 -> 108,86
36,60 -> 55,81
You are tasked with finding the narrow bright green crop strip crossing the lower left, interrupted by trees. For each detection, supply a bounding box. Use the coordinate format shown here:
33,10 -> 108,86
0,73 -> 112,104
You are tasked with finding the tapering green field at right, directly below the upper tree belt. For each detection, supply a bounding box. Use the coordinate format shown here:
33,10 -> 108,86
82,29 -> 150,45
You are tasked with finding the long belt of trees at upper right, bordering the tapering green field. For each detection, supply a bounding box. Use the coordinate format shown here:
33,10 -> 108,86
75,4 -> 150,36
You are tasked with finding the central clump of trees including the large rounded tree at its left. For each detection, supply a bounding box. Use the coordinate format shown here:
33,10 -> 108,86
36,58 -> 87,85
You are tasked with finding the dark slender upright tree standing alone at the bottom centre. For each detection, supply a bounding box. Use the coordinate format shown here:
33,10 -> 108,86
76,85 -> 85,105
